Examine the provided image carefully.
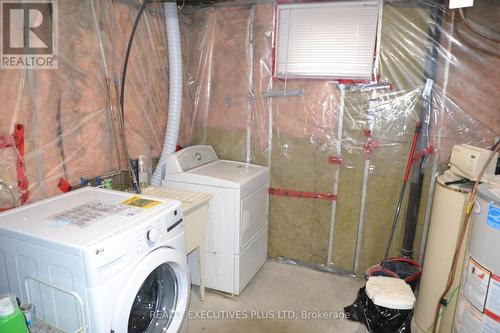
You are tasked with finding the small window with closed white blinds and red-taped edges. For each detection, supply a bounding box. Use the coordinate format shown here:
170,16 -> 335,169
274,0 -> 379,79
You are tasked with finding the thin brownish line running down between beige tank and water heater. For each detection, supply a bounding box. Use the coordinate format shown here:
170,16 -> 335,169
432,142 -> 500,333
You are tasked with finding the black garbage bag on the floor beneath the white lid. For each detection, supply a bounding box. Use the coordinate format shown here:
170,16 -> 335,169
344,287 -> 413,333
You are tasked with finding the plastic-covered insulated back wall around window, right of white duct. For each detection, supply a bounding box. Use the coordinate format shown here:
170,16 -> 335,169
180,3 -> 500,273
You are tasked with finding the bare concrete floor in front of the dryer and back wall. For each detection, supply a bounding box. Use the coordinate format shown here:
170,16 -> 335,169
189,261 -> 366,333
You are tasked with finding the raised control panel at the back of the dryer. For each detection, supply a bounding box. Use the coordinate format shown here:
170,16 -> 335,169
166,145 -> 218,175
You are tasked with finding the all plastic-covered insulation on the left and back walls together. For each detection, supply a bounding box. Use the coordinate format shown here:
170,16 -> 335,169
0,0 -> 500,273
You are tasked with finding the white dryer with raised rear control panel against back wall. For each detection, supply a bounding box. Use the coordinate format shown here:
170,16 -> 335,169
163,146 -> 270,295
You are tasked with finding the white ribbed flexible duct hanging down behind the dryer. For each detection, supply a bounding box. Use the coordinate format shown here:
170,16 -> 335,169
151,1 -> 186,186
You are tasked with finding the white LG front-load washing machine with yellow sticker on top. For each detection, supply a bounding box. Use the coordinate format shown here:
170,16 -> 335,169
0,187 -> 190,333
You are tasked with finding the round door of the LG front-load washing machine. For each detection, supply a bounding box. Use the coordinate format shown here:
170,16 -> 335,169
111,248 -> 189,333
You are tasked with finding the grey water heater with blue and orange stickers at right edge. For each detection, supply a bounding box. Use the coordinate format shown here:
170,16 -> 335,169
453,184 -> 500,333
